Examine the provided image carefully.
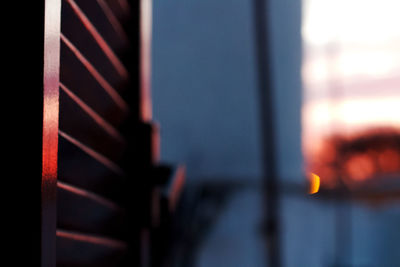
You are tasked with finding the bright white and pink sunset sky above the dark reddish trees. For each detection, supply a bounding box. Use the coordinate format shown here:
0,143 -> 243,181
302,0 -> 400,156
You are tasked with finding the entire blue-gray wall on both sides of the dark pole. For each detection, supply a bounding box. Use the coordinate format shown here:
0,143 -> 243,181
152,0 -> 302,180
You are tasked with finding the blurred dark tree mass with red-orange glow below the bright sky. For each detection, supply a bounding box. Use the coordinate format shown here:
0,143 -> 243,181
307,128 -> 400,188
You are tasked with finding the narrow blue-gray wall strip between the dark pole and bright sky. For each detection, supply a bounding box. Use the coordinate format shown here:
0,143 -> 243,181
266,0 -> 304,182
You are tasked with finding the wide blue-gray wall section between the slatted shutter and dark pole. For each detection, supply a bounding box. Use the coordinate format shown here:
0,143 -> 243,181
152,0 -> 261,180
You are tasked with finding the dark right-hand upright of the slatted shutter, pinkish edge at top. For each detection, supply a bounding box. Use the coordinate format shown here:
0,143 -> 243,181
123,0 -> 152,266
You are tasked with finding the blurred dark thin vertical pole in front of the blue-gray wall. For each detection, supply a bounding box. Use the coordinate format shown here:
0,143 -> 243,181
253,0 -> 281,267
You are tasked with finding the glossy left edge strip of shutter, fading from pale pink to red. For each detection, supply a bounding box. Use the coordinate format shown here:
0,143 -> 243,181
41,0 -> 61,267
